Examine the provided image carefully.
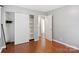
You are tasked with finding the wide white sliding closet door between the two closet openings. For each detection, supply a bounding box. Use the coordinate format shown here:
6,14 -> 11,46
15,13 -> 29,44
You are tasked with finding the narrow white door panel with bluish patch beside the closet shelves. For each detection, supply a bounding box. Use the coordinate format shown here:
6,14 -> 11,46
34,16 -> 39,41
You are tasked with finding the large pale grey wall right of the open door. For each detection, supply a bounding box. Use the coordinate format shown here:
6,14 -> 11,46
51,5 -> 79,48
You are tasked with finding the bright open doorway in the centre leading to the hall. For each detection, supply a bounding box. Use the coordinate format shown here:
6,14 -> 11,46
40,16 -> 46,48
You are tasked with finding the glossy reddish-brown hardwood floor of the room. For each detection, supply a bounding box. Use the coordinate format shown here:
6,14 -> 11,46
2,38 -> 79,53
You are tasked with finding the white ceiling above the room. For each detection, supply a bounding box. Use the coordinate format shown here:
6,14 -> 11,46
15,5 -> 64,12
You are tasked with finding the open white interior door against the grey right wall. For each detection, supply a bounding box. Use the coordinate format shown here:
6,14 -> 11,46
46,15 -> 53,41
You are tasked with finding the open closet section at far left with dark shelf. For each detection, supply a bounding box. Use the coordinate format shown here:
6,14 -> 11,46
5,12 -> 15,45
